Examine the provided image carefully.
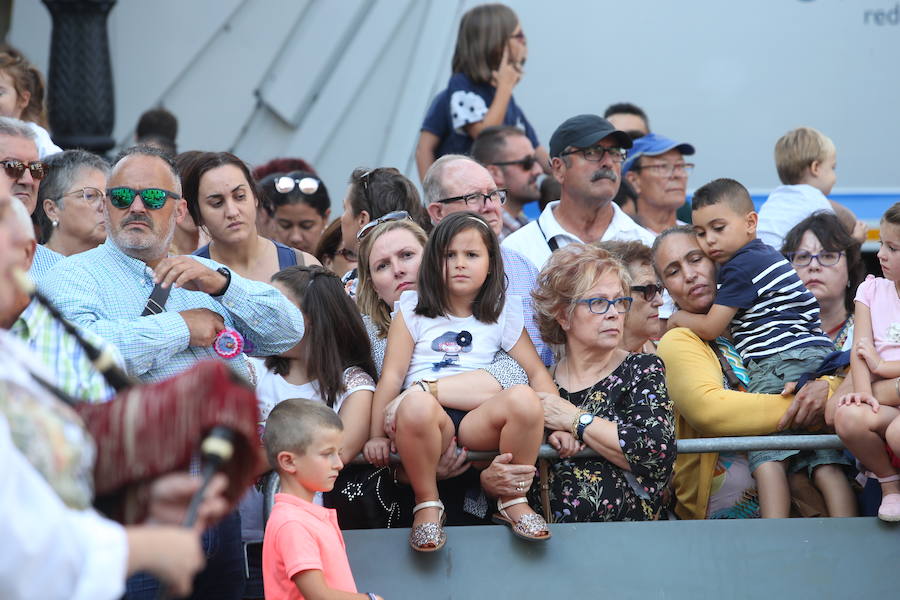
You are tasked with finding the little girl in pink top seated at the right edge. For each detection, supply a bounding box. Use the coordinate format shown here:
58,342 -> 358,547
834,202 -> 900,521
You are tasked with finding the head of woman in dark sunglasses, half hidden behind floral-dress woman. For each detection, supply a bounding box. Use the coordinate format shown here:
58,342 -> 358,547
597,241 -> 663,354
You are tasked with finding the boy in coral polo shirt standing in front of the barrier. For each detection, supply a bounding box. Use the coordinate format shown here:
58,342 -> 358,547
263,400 -> 381,600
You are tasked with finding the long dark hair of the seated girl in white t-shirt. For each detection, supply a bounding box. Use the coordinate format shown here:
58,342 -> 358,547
416,211 -> 506,323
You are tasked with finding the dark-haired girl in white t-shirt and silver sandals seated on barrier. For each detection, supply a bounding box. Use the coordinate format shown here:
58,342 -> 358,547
364,213 -> 556,552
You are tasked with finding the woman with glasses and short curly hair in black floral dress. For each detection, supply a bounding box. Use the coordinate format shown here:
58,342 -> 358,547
533,243 -> 675,522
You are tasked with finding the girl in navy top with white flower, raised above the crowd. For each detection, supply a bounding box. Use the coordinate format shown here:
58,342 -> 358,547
416,4 -> 549,179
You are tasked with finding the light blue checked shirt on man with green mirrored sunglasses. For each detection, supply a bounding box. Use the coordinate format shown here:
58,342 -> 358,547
39,240 -> 303,381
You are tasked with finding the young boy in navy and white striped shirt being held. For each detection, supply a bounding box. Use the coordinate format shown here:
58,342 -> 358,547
669,179 -> 856,518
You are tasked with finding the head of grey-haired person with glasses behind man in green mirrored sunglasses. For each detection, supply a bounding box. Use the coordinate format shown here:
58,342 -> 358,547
35,150 -> 109,256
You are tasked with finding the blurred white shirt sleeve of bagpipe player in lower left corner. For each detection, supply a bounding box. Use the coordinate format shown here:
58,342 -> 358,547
0,415 -> 128,600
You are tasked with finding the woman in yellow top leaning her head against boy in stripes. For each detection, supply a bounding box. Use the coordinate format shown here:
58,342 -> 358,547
653,226 -> 860,519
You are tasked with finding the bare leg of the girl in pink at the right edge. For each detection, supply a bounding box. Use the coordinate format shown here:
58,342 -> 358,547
834,404 -> 900,496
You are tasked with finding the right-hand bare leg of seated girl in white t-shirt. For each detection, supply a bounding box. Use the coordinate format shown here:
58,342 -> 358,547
459,385 -> 544,520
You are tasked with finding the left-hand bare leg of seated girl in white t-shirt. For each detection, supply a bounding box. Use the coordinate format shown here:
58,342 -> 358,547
394,392 -> 454,525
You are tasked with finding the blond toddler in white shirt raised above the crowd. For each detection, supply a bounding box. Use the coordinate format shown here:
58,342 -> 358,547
759,127 -> 866,250
